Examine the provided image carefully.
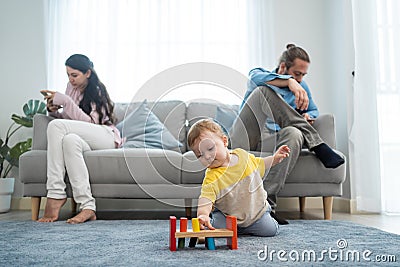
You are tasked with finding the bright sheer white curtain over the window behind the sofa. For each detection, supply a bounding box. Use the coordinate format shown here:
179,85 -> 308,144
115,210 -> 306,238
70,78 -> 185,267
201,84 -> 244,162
46,0 -> 273,103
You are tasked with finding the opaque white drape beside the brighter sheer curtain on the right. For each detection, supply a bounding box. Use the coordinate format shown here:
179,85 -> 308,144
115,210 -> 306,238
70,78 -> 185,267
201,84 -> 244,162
349,0 -> 381,212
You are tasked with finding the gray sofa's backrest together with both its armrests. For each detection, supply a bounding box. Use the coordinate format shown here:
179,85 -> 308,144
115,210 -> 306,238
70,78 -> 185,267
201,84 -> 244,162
32,100 -> 336,152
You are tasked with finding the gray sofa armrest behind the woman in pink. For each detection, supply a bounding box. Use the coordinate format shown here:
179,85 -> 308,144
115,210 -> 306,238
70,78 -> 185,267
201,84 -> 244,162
32,114 -> 55,150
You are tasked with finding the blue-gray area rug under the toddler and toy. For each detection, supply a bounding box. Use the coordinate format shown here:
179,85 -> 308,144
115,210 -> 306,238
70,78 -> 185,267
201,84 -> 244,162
0,221 -> 400,266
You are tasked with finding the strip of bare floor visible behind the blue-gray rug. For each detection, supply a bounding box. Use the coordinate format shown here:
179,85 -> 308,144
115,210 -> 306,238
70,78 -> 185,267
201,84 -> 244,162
0,209 -> 400,235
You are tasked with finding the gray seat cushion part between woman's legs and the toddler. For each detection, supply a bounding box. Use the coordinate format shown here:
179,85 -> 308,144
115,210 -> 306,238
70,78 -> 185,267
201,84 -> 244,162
84,148 -> 182,184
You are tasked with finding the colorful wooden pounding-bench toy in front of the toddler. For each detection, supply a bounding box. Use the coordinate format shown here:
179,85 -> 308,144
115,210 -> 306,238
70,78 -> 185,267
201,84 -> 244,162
169,216 -> 238,251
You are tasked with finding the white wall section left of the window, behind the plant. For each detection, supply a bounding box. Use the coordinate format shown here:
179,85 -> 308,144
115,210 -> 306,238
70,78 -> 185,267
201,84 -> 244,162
0,0 -> 46,195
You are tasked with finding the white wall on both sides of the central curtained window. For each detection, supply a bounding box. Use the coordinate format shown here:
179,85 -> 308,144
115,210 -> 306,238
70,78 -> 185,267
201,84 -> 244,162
0,0 -> 354,198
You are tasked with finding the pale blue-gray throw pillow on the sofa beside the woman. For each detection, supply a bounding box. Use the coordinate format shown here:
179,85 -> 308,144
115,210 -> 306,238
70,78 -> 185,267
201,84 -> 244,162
116,100 -> 183,150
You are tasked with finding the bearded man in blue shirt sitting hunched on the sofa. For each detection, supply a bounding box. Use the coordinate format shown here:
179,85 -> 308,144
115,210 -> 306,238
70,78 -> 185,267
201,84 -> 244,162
230,44 -> 344,224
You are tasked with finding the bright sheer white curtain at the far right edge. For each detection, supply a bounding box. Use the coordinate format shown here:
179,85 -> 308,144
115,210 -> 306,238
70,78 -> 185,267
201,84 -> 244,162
376,0 -> 400,213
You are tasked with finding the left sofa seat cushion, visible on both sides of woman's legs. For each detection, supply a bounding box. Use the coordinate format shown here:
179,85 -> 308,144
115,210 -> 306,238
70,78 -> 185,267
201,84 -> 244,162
20,148 -> 182,184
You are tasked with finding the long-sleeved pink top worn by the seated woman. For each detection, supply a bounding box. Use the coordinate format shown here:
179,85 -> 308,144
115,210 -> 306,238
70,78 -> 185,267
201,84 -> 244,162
50,83 -> 122,148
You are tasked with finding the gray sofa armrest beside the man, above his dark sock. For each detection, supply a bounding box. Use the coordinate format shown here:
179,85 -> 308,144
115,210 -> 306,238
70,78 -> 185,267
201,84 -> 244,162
313,114 -> 336,148
